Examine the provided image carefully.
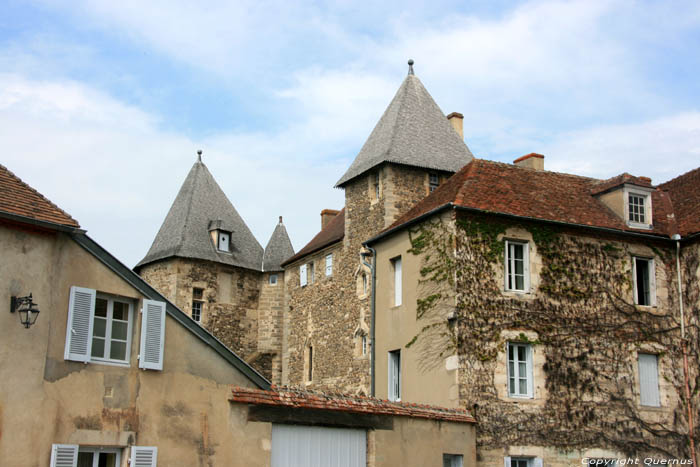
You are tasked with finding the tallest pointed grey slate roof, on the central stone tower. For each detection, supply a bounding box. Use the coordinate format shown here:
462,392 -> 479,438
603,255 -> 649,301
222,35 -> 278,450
335,68 -> 474,187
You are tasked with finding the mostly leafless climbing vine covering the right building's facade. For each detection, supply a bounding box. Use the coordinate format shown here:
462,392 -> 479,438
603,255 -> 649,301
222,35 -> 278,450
409,215 -> 700,457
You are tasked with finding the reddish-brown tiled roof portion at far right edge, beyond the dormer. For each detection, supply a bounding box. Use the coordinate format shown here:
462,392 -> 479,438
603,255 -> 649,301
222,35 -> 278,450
659,167 -> 700,236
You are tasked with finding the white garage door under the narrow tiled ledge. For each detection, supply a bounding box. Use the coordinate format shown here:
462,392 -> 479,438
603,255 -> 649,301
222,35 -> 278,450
271,424 -> 367,467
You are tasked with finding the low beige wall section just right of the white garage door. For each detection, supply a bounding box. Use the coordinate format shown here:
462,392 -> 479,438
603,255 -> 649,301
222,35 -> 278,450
367,417 -> 478,467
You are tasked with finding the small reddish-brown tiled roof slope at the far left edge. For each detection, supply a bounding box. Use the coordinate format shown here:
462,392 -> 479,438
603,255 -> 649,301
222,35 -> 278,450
0,165 -> 80,227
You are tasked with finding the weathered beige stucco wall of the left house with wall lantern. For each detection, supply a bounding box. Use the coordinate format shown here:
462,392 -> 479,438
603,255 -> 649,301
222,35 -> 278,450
0,226 -> 270,467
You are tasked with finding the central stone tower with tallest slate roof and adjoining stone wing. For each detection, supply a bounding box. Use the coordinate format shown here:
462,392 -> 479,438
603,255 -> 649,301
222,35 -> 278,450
283,62 -> 473,394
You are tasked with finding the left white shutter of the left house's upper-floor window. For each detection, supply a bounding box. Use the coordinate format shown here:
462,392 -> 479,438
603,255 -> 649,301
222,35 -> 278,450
63,286 -> 97,362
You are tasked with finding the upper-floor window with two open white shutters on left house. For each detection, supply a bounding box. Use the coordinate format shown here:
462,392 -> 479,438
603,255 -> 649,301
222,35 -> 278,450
64,287 -> 165,370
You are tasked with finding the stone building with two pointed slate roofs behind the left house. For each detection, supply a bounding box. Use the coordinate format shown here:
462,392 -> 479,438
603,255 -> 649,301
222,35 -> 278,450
134,153 -> 294,382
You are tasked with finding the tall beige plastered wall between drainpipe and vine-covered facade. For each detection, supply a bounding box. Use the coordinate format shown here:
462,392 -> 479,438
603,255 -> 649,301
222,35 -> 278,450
374,216 -> 459,407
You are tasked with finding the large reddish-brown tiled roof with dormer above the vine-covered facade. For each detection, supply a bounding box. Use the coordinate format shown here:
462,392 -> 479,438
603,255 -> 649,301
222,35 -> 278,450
380,159 -> 676,241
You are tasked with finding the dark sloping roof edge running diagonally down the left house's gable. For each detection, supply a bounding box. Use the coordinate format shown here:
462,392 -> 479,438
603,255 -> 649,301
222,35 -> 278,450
71,232 -> 271,389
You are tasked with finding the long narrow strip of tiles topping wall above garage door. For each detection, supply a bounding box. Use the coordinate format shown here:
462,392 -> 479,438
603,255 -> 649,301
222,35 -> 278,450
230,386 -> 475,423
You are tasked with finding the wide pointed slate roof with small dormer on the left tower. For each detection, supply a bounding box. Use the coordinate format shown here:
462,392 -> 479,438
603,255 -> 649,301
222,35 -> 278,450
136,160 -> 263,271
